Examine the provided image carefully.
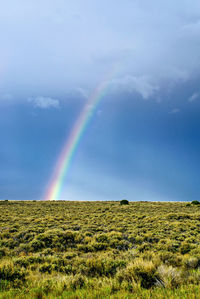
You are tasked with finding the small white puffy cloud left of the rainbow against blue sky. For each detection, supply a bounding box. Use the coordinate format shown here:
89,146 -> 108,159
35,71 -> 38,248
28,96 -> 60,109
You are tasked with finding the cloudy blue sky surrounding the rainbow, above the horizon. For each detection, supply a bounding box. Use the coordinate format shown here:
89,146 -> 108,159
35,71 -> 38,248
0,0 -> 200,201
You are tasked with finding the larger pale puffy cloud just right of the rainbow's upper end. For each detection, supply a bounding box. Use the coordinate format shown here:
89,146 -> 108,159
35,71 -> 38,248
110,75 -> 158,100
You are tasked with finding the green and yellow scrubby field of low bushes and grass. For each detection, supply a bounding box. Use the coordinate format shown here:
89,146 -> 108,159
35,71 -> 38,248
0,201 -> 200,299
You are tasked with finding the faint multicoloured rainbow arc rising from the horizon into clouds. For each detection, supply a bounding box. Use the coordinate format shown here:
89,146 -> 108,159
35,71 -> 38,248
44,67 -> 116,201
